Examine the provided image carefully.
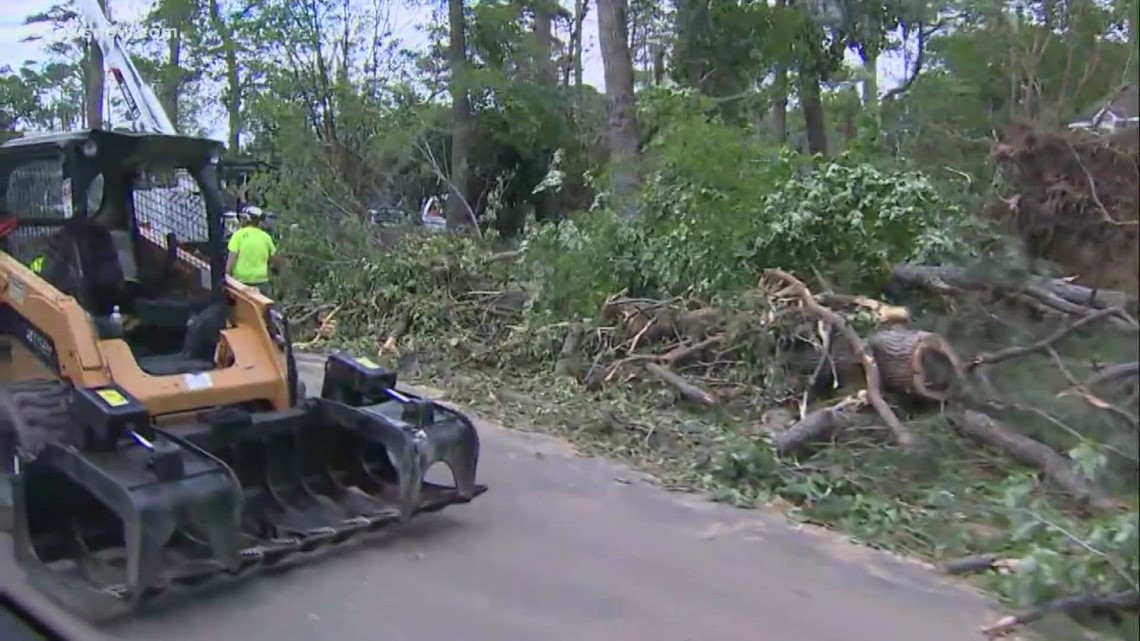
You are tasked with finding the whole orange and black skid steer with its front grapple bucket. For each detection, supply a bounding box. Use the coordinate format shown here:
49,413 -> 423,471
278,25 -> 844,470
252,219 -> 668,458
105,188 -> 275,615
0,130 -> 486,619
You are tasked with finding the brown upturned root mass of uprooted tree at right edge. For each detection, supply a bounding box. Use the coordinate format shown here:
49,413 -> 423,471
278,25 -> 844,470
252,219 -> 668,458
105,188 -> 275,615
988,124 -> 1140,293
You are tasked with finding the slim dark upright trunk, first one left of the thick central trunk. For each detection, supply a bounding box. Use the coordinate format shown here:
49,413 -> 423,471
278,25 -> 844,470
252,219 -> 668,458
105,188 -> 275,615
447,0 -> 474,230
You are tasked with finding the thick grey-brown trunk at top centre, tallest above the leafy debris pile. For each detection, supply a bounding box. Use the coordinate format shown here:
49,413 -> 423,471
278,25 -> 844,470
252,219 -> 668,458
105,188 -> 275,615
597,0 -> 641,209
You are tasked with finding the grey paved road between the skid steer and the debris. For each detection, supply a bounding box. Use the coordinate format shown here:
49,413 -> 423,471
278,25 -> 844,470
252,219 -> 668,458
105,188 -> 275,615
0,355 -> 992,641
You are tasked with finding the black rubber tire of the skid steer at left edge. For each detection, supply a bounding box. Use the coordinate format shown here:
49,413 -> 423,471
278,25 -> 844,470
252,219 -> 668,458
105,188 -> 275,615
0,379 -> 71,532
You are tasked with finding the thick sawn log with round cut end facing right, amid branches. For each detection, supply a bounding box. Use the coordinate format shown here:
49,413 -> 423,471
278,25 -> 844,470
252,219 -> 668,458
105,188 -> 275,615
869,327 -> 962,403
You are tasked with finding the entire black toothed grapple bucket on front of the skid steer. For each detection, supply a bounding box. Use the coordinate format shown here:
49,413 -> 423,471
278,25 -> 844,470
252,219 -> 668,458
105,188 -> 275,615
13,356 -> 487,618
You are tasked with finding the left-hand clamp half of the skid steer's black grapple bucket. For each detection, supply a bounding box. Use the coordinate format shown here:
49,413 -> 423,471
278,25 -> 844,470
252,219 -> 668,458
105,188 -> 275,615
13,431 -> 242,616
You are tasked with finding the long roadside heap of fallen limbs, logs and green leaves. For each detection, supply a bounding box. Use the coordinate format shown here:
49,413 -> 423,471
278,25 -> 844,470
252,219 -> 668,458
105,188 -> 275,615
278,142 -> 1140,634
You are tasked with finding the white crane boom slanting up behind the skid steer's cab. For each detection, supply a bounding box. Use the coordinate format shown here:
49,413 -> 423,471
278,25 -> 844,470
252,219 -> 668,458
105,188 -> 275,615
76,0 -> 178,136
